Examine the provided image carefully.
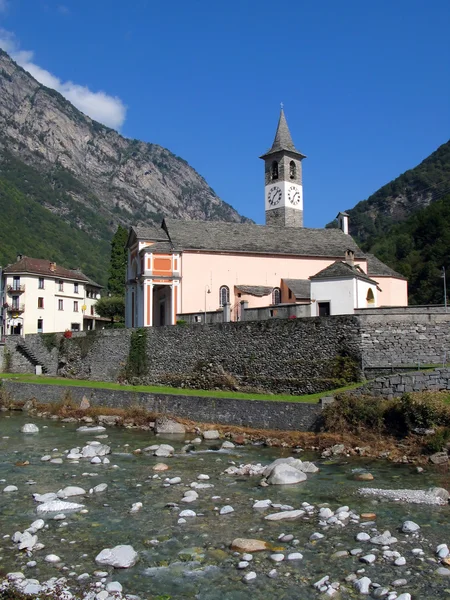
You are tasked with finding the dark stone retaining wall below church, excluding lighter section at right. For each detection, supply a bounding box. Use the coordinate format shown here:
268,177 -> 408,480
4,316 -> 361,394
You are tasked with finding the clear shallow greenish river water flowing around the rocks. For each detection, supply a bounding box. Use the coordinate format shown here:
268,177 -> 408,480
0,413 -> 450,600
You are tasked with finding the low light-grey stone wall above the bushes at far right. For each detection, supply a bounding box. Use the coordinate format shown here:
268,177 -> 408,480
350,368 -> 450,398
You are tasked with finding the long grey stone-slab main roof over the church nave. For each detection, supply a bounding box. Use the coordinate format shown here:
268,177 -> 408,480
162,218 -> 365,259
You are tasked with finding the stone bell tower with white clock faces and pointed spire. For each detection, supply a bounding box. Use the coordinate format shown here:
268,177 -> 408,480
260,105 -> 306,227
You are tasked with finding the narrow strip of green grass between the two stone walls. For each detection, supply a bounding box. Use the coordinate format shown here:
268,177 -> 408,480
0,373 -> 363,403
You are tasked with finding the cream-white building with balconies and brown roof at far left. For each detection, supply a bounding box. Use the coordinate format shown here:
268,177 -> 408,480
2,255 -> 101,335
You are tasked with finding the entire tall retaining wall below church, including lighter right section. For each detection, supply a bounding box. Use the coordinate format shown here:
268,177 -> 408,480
6,310 -> 450,394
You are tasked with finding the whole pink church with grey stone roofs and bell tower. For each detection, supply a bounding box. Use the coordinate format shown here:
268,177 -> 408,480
125,109 -> 408,327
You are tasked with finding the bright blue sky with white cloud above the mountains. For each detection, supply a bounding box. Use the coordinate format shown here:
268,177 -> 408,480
0,0 -> 450,227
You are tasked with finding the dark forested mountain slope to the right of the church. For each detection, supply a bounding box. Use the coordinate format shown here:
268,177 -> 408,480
327,141 -> 450,304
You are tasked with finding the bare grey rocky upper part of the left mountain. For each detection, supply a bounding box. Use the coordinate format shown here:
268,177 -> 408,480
0,50 -> 246,234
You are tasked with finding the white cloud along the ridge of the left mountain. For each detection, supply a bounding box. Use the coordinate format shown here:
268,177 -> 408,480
0,29 -> 127,129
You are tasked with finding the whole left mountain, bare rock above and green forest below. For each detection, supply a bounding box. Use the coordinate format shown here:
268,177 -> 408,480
0,49 -> 248,283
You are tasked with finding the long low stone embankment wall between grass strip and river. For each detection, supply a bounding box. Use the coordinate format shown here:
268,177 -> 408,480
2,379 -> 322,431
